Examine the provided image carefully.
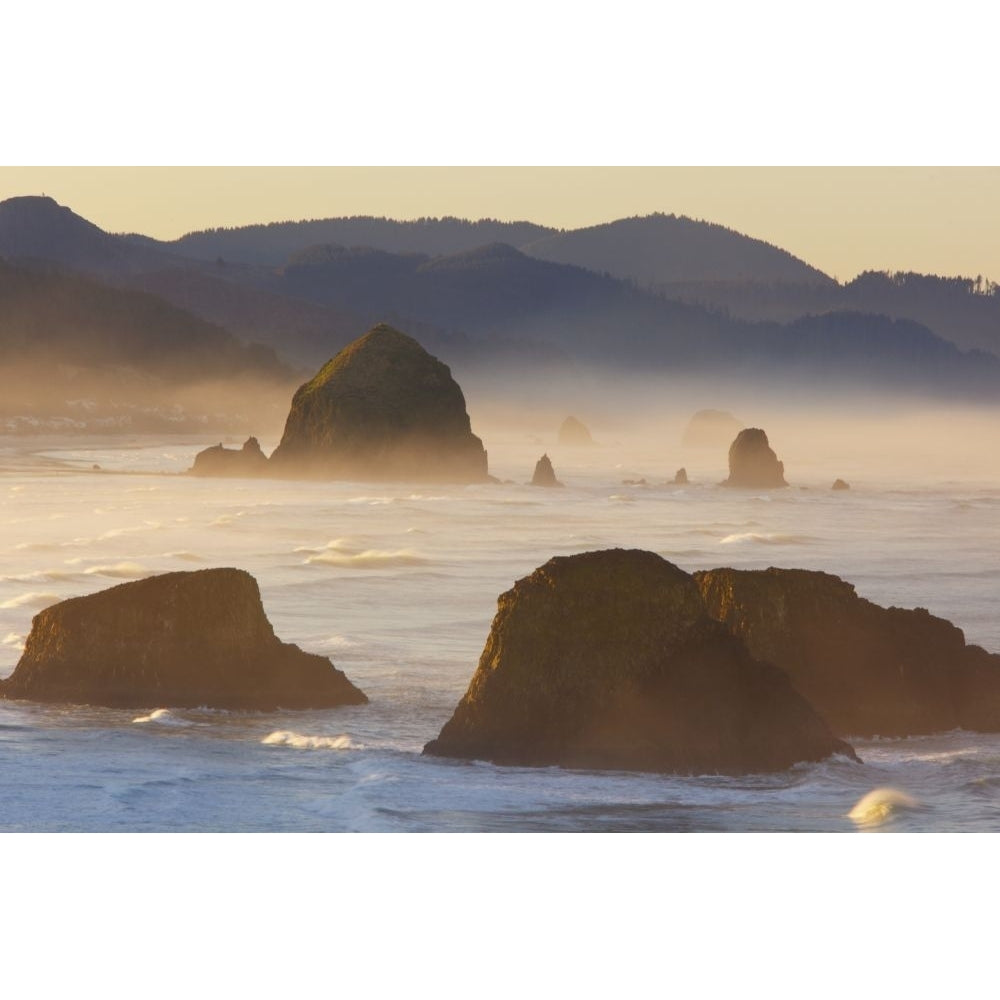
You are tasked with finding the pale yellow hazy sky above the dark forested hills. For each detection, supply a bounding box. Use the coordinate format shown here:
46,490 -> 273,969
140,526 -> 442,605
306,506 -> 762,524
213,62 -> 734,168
0,167 -> 1000,280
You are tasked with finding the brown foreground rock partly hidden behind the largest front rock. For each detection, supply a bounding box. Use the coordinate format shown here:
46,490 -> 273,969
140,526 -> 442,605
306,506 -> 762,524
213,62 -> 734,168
694,568 -> 1000,736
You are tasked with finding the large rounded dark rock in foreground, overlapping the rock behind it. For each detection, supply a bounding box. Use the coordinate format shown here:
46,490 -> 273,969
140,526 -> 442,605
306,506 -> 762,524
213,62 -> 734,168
424,549 -> 854,774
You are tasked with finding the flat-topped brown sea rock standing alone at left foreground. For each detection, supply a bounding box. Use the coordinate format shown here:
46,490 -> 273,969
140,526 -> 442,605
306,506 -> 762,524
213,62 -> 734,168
0,569 -> 368,711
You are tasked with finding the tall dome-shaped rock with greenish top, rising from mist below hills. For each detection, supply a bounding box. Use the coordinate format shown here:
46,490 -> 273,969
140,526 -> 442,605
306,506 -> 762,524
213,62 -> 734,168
271,323 -> 489,483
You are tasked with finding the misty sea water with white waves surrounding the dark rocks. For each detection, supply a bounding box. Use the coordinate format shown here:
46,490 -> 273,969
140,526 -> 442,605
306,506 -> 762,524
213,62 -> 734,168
0,434 -> 1000,831
